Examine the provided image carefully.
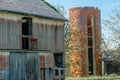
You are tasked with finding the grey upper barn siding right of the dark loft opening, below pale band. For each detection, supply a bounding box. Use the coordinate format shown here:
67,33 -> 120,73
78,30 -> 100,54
33,20 -> 64,52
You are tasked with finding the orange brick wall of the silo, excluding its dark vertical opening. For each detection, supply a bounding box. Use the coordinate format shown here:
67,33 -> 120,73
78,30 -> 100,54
69,7 -> 102,77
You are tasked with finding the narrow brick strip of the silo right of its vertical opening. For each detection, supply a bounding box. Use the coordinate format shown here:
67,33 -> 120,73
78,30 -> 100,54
94,9 -> 102,76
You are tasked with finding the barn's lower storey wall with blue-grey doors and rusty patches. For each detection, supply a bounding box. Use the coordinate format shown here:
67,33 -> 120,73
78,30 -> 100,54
0,50 -> 65,80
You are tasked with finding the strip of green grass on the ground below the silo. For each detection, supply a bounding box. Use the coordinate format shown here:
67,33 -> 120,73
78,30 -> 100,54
65,74 -> 120,80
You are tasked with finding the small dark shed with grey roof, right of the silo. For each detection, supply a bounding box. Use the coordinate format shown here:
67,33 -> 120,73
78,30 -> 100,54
102,51 -> 120,75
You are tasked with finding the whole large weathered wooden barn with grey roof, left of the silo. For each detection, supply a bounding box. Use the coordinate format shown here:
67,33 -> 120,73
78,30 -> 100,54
0,0 -> 66,80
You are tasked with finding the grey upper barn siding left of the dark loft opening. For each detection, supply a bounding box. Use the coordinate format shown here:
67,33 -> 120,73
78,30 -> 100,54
0,13 -> 21,49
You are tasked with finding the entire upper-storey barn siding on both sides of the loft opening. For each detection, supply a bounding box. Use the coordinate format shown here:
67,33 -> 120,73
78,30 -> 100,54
0,12 -> 64,52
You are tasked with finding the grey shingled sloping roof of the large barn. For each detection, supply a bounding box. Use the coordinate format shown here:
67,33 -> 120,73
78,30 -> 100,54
0,0 -> 66,20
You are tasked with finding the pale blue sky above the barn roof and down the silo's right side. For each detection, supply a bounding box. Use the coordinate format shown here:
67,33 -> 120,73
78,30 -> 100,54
45,0 -> 120,47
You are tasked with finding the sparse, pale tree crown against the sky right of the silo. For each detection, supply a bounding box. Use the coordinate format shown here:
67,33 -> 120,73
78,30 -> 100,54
103,6 -> 120,47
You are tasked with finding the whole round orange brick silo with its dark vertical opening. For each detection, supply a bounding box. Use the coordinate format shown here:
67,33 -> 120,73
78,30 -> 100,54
69,7 -> 102,77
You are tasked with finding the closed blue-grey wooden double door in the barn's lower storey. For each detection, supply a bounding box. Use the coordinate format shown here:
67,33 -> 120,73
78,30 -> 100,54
10,52 -> 40,80
